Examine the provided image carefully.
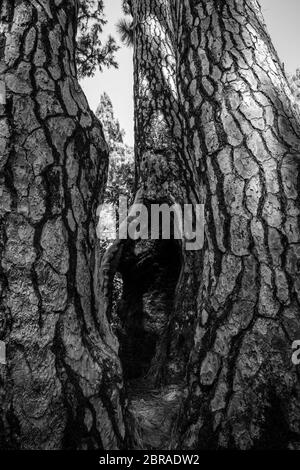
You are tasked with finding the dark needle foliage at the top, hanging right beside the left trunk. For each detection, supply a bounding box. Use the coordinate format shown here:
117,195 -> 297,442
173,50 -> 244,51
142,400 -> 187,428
76,0 -> 119,78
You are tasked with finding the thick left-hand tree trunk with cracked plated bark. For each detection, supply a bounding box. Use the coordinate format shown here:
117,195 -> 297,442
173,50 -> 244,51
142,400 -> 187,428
0,0 -> 124,449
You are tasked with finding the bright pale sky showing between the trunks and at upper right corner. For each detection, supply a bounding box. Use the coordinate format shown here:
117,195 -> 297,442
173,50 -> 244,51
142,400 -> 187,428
81,0 -> 300,145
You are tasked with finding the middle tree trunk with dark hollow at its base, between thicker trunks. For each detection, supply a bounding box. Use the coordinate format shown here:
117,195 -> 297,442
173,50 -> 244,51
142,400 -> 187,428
117,0 -> 190,449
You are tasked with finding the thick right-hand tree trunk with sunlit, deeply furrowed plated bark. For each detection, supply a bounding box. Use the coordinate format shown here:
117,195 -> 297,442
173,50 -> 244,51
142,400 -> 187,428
179,0 -> 300,449
